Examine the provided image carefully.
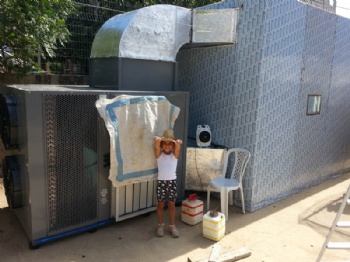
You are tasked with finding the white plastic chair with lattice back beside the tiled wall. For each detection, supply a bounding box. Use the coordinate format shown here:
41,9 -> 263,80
207,148 -> 251,220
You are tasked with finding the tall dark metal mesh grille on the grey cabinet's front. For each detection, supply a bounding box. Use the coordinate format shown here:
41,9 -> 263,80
44,95 -> 98,232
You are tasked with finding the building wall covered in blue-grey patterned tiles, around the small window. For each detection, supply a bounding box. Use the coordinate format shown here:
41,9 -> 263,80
177,0 -> 350,211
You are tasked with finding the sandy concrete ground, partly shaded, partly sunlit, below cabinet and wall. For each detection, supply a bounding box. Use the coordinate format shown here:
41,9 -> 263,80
0,173 -> 350,262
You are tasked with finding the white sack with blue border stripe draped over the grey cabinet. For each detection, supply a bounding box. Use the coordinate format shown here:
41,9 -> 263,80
96,95 -> 180,187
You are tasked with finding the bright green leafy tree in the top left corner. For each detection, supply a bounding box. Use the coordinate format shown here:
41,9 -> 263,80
0,0 -> 75,72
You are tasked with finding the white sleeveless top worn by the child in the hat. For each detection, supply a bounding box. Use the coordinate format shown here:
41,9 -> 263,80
157,152 -> 177,180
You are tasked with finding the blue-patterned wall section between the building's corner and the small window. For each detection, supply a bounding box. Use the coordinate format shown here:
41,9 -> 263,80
252,1 -> 306,210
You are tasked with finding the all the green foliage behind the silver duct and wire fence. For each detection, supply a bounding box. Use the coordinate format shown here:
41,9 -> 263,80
0,0 -> 219,74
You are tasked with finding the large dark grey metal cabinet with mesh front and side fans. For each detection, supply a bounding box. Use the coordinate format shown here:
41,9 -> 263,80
0,85 -> 189,247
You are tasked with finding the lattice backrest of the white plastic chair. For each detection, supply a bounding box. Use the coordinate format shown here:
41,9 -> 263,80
222,148 -> 251,182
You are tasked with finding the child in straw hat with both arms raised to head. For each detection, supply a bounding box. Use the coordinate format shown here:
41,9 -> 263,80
154,129 -> 182,238
